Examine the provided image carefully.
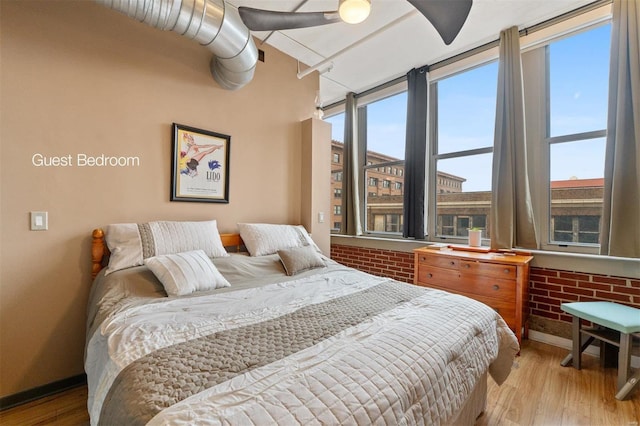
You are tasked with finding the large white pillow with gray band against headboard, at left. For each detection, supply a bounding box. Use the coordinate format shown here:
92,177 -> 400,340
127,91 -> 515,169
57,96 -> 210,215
105,220 -> 229,275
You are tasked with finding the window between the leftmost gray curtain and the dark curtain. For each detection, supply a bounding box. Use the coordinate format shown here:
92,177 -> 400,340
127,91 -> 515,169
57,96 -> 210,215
359,91 -> 407,233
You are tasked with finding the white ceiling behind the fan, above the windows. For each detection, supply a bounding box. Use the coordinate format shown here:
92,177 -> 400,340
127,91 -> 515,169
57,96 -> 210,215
227,0 -> 593,105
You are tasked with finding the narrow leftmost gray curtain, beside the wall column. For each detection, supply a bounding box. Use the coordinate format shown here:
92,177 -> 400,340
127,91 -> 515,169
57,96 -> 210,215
342,93 -> 362,235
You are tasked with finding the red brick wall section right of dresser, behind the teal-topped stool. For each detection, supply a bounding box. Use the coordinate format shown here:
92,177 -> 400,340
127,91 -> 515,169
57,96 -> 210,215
529,267 -> 640,322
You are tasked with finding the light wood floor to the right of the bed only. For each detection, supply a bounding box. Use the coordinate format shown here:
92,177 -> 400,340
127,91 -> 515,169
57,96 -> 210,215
476,341 -> 640,426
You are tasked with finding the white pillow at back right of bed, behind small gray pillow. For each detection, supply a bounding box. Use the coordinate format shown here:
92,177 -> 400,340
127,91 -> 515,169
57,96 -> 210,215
238,223 -> 320,256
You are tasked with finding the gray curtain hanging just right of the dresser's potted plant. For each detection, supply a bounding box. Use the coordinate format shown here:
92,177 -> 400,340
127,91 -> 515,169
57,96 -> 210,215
489,27 -> 538,250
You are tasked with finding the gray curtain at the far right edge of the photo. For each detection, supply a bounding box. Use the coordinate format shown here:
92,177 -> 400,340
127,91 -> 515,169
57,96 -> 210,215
600,0 -> 640,257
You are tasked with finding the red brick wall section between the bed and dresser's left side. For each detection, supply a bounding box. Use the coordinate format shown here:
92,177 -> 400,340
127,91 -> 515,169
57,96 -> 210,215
331,244 -> 413,283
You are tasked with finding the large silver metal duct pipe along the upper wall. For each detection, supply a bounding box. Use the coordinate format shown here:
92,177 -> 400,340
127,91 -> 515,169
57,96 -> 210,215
95,0 -> 258,90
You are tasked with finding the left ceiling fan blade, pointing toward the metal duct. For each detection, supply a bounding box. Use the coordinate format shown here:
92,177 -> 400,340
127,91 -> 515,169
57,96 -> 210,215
238,6 -> 340,31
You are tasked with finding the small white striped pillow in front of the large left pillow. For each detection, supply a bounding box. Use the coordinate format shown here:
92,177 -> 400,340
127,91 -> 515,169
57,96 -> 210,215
144,250 -> 231,296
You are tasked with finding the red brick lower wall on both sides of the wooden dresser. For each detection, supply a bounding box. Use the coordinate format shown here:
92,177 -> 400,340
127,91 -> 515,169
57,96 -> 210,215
331,244 -> 640,322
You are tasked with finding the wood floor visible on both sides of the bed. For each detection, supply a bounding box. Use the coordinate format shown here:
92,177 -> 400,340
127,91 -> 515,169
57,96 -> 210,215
0,341 -> 640,426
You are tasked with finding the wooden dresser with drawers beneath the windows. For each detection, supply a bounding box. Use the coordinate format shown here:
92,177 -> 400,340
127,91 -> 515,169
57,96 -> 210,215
414,248 -> 533,342
